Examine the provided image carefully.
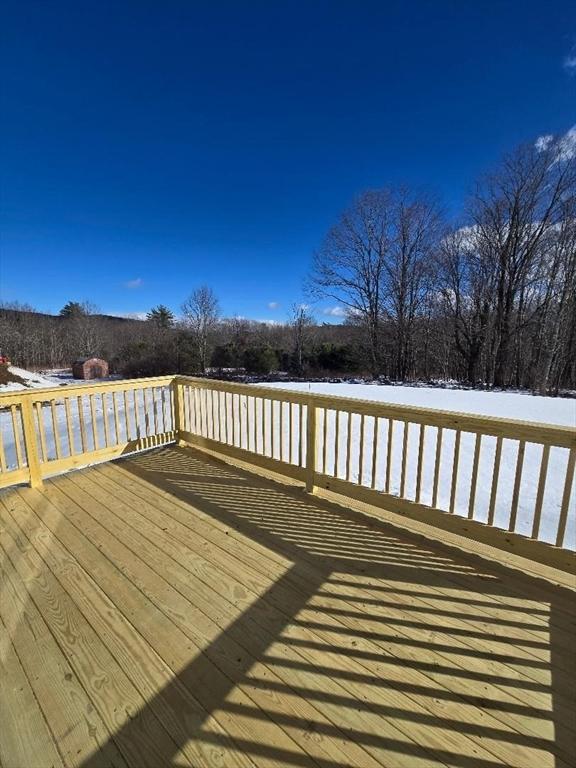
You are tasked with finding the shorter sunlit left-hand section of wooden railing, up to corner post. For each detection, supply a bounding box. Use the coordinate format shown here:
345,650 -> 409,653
0,376 -> 175,487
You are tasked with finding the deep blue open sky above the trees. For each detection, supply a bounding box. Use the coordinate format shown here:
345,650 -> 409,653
0,0 -> 576,320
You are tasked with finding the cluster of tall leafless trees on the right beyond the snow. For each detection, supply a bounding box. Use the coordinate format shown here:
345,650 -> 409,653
311,130 -> 576,392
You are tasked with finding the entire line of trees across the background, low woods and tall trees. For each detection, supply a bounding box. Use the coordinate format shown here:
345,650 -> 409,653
0,130 -> 576,393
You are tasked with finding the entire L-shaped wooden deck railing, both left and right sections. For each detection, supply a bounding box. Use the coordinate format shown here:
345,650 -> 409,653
0,376 -> 576,569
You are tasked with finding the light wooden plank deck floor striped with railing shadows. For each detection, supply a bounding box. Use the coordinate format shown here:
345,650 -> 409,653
0,447 -> 576,768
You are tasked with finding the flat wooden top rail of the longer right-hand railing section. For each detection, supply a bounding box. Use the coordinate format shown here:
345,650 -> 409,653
176,376 -> 576,448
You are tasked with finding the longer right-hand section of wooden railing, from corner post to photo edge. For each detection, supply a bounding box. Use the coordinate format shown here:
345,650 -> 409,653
175,376 -> 576,572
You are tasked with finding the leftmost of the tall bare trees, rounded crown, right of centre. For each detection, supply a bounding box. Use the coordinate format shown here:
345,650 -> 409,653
311,188 -> 441,379
